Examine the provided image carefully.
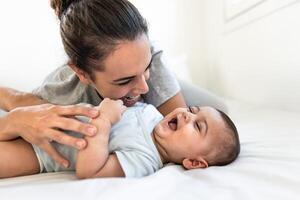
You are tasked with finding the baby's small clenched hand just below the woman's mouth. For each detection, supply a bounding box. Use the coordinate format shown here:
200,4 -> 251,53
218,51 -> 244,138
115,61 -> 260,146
98,98 -> 126,125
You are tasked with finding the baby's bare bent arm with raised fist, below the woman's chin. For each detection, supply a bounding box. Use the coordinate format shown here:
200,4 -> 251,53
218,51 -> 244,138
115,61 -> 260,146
76,99 -> 126,178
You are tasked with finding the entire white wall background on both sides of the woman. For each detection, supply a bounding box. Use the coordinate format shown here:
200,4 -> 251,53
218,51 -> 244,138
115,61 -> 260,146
0,0 -> 300,111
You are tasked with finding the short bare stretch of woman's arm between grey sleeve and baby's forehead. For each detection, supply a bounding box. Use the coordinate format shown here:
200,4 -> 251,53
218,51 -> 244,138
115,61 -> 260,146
157,92 -> 186,116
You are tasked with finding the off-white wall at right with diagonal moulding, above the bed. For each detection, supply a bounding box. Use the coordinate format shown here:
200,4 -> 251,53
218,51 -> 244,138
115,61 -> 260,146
203,0 -> 300,111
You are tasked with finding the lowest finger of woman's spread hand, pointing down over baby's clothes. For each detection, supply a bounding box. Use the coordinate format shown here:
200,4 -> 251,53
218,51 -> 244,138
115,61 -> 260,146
39,141 -> 70,168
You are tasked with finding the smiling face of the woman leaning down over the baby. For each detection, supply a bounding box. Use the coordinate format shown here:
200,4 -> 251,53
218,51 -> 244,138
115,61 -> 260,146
88,34 -> 152,106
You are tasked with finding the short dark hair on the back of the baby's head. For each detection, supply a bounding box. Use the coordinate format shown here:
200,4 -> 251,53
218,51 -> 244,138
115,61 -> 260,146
207,109 -> 240,166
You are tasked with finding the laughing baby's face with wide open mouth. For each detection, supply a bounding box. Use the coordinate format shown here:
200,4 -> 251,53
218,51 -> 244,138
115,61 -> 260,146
154,107 -> 225,162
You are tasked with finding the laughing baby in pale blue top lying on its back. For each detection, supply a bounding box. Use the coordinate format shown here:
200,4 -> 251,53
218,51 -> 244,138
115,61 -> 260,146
0,99 -> 240,178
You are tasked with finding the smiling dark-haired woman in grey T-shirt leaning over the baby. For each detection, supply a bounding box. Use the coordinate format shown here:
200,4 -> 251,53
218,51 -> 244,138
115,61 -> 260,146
0,0 -> 225,170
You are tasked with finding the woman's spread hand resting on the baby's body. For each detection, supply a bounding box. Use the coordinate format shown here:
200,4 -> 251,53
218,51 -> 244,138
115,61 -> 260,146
6,104 -> 99,167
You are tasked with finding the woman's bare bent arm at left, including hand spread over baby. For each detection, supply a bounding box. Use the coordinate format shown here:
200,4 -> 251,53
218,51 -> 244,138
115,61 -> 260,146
0,87 -> 103,167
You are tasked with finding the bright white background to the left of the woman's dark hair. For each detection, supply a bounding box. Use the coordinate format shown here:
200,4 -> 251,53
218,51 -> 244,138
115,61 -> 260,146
0,0 -> 65,91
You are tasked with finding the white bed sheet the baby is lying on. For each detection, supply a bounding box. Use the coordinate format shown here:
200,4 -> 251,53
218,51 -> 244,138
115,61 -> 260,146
0,101 -> 300,200
